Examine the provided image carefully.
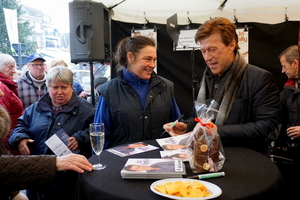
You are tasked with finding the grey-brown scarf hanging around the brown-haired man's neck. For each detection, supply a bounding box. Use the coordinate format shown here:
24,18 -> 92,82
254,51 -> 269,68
197,51 -> 247,125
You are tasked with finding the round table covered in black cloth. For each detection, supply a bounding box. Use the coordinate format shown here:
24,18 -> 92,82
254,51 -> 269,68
76,140 -> 285,200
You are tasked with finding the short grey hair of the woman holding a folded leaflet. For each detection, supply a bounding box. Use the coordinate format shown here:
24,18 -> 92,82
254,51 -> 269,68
46,66 -> 73,87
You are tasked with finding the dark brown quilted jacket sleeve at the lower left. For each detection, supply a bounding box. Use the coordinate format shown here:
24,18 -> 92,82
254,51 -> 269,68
0,155 -> 56,200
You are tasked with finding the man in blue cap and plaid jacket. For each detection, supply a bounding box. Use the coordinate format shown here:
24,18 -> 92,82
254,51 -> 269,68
17,53 -> 47,109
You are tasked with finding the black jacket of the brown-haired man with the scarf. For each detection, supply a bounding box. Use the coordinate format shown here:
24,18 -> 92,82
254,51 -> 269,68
186,64 -> 281,154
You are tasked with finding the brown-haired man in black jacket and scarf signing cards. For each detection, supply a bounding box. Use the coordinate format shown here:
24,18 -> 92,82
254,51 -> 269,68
164,17 -> 281,156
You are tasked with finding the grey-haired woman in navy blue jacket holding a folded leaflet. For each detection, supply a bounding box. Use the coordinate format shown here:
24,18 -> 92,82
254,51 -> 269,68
9,66 -> 95,200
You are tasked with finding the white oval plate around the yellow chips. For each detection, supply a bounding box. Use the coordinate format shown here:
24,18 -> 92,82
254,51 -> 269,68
150,178 -> 222,200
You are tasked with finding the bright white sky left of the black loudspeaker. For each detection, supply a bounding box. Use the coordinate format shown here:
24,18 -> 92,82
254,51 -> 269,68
20,0 -> 72,32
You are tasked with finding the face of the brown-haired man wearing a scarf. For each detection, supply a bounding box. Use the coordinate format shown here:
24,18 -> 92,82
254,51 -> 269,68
200,33 -> 236,76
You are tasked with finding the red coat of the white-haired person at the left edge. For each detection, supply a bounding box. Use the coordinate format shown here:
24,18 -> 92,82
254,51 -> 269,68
0,72 -> 24,154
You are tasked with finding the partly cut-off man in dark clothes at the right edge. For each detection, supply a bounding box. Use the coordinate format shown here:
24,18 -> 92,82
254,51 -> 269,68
277,45 -> 300,167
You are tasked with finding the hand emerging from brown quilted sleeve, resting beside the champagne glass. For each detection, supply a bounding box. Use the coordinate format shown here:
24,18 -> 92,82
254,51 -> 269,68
56,154 -> 93,173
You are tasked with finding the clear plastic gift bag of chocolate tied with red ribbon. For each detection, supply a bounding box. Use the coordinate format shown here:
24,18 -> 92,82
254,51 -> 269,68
188,100 -> 225,173
